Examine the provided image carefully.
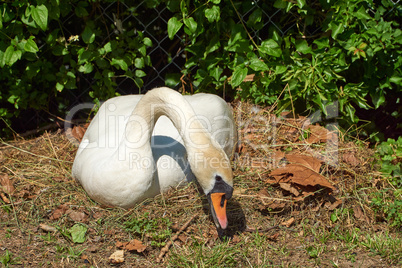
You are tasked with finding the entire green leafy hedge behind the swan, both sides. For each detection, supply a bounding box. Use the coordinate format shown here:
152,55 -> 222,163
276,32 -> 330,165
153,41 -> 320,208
0,0 -> 402,138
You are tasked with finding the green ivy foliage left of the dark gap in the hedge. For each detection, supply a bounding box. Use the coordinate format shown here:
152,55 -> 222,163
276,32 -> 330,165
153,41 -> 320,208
0,0 -> 152,131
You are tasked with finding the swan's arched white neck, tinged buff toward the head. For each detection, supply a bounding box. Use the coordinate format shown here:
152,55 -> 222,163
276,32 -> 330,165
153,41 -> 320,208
119,88 -> 230,191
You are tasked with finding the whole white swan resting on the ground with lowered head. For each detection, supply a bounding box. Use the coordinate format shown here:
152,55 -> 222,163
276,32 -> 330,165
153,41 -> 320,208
72,87 -> 237,229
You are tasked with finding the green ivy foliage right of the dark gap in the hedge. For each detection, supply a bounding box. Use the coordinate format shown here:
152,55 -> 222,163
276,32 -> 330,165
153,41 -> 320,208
168,0 -> 402,134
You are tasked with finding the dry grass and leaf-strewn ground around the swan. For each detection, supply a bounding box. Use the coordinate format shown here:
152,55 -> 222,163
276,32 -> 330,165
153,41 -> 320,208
0,103 -> 402,267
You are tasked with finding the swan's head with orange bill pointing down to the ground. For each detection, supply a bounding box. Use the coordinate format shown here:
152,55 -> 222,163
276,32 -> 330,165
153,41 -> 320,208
191,149 -> 233,229
